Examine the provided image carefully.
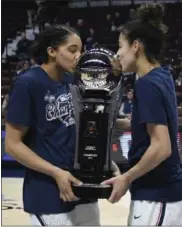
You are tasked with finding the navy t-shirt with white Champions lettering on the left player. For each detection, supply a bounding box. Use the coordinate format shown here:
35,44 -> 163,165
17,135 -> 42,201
7,67 -> 96,214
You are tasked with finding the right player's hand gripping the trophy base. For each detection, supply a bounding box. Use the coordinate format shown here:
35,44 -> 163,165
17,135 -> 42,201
102,174 -> 130,203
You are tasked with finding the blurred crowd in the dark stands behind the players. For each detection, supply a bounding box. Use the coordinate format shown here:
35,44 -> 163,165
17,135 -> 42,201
2,1 -> 182,126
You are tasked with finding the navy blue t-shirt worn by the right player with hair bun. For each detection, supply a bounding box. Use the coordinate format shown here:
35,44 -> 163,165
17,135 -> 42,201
128,67 -> 182,202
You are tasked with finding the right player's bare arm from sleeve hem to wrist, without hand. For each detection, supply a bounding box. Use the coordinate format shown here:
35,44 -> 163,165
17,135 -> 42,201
124,124 -> 171,183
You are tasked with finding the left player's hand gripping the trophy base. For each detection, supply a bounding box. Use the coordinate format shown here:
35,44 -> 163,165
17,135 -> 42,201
54,169 -> 82,202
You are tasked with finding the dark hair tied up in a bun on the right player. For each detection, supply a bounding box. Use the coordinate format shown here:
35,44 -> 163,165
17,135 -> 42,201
121,3 -> 167,63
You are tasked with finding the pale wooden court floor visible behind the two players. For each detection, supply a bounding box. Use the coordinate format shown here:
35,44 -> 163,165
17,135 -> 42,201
2,178 -> 130,226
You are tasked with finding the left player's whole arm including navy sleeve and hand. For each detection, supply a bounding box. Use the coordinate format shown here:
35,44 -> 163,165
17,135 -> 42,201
5,76 -> 81,201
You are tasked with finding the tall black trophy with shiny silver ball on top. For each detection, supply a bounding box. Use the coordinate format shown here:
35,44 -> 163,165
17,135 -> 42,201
70,48 -> 123,199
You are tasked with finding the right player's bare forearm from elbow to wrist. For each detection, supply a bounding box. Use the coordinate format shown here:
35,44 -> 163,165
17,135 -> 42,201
124,146 -> 170,183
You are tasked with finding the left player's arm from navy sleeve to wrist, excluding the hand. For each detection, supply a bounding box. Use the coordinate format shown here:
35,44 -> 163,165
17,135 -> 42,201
5,79 -> 58,176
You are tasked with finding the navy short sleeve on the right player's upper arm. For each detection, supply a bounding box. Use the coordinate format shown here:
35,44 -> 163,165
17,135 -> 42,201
136,79 -> 167,125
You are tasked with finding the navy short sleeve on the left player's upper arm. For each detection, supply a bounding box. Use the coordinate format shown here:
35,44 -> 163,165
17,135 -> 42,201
6,80 -> 33,127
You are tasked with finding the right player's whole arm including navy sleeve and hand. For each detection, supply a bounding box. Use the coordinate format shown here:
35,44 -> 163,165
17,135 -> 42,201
104,80 -> 172,203
